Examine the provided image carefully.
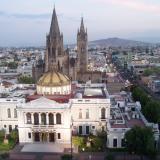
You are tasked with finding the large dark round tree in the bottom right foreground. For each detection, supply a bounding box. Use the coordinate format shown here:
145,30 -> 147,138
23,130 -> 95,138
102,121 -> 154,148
125,126 -> 156,159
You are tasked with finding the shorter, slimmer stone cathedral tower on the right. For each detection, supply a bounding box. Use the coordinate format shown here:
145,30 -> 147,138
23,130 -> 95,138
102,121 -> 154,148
77,18 -> 88,72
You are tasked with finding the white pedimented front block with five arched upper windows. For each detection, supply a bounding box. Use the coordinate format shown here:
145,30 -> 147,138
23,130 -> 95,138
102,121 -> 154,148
18,97 -> 71,144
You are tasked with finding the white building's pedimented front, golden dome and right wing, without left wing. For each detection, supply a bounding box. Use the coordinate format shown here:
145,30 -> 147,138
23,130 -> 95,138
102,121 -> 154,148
17,72 -> 110,145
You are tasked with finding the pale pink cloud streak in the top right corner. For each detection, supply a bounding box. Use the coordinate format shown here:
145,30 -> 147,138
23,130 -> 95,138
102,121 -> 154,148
94,0 -> 160,13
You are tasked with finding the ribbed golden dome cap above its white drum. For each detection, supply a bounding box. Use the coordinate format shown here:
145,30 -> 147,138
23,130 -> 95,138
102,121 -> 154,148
37,72 -> 71,87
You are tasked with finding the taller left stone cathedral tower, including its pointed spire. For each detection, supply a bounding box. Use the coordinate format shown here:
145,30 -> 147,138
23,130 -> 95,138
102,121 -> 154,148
45,8 -> 64,72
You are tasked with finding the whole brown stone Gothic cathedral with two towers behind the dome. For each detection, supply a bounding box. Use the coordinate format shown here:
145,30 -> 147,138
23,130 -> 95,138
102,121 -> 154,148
33,8 -> 102,82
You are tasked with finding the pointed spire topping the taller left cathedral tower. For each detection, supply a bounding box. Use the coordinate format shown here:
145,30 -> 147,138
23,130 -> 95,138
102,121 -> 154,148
50,5 -> 60,37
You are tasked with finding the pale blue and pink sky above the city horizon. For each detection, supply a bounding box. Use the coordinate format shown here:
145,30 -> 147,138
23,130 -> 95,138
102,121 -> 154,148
0,0 -> 160,47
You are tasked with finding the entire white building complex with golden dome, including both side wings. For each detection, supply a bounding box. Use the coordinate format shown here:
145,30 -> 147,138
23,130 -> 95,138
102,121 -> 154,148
0,69 -> 159,148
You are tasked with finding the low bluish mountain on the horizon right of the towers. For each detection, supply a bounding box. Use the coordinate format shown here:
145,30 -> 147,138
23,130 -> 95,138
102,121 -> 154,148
89,38 -> 153,47
